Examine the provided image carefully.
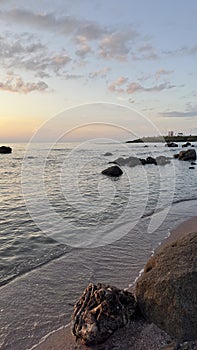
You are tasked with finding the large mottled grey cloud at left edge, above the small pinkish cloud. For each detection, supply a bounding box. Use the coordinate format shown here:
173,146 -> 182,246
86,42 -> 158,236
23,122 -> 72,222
0,33 -> 71,78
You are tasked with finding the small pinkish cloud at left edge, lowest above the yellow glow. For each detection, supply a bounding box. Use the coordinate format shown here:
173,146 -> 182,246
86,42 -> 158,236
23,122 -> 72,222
0,77 -> 48,94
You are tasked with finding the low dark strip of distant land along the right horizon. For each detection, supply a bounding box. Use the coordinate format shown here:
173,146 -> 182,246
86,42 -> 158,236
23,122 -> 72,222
126,135 -> 197,143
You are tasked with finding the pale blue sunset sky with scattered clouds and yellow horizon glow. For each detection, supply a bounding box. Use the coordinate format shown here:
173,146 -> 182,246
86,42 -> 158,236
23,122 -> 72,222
0,0 -> 197,143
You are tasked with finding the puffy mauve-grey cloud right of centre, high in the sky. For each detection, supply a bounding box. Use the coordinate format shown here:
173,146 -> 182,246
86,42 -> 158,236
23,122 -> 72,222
99,30 -> 138,61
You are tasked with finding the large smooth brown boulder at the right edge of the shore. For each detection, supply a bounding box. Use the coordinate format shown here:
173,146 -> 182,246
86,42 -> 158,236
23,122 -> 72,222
135,233 -> 197,340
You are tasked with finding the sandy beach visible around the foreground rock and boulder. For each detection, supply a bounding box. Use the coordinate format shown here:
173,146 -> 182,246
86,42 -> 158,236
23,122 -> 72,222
31,216 -> 197,350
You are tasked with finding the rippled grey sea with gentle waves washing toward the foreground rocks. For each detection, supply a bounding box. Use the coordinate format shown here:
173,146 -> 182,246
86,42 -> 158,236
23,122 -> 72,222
0,139 -> 197,350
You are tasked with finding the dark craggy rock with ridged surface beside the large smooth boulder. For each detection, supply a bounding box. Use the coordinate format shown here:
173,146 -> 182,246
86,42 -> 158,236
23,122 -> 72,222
72,283 -> 136,345
